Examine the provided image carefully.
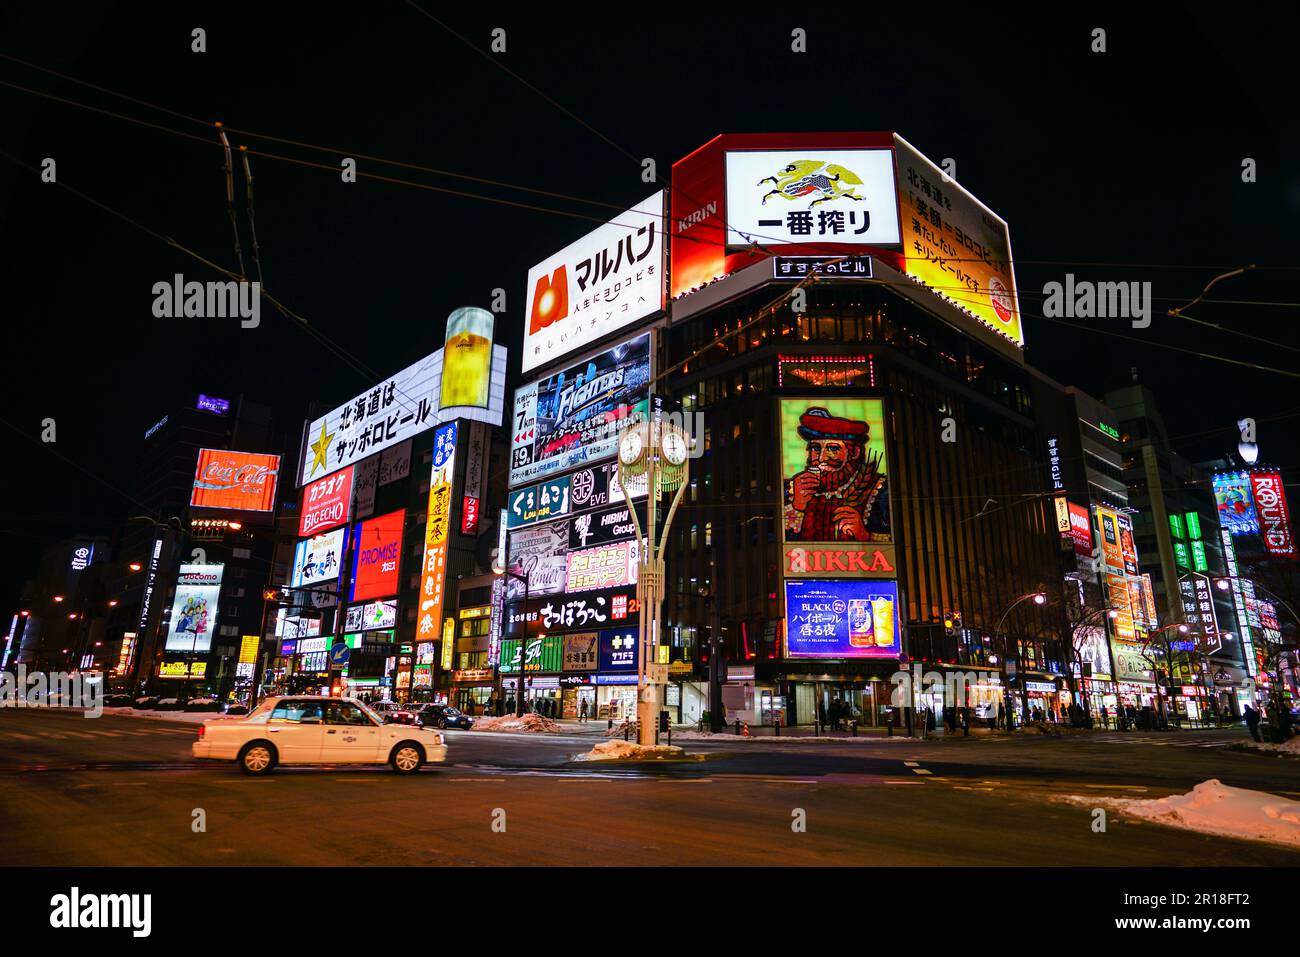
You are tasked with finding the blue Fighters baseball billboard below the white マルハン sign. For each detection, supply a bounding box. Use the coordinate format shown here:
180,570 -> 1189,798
510,334 -> 650,486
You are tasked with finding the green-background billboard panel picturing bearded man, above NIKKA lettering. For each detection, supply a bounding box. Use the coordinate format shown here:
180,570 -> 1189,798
780,397 -> 896,546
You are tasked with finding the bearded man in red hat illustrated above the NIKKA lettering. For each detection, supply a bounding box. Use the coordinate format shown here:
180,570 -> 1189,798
785,407 -> 891,542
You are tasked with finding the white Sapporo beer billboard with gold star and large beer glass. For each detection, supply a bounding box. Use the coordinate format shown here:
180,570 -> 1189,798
298,309 -> 506,485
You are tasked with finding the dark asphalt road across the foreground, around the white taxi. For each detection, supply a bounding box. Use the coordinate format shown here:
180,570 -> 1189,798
0,709 -> 1300,866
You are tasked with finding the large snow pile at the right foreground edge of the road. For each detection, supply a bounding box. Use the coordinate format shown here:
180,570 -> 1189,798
1066,779 -> 1300,848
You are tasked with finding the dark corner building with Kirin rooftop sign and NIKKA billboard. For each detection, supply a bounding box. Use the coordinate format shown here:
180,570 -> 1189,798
658,134 -> 1063,726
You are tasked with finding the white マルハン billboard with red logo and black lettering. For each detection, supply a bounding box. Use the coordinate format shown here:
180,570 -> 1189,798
523,191 -> 664,372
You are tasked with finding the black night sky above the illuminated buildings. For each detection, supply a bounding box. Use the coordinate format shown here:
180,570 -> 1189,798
0,0 -> 1300,611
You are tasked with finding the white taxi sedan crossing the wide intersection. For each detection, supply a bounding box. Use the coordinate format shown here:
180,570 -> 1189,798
191,694 -> 447,774
